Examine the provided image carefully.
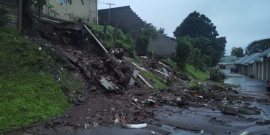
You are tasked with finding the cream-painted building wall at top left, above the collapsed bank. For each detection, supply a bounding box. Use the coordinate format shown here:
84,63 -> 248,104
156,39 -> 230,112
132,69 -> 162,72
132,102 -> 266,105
44,0 -> 97,24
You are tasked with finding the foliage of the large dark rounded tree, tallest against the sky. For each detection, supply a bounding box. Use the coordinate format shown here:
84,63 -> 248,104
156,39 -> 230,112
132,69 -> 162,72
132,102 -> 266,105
174,11 -> 227,66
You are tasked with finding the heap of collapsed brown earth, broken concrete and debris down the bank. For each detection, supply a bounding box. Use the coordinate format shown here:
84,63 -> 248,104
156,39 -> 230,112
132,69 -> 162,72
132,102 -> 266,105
26,23 -> 260,128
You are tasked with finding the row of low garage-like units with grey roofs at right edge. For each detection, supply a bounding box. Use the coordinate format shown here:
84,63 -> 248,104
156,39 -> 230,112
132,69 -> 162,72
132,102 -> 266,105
235,48 -> 270,80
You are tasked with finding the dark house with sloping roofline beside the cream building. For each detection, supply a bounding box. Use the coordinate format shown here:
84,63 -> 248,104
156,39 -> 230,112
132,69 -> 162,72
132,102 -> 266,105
98,6 -> 144,40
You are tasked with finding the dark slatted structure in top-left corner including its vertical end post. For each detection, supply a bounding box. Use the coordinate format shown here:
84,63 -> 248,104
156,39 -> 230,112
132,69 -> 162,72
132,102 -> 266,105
0,0 -> 22,30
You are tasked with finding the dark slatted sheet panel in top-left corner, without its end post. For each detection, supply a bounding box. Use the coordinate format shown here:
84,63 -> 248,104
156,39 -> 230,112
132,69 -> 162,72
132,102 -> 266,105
0,0 -> 19,29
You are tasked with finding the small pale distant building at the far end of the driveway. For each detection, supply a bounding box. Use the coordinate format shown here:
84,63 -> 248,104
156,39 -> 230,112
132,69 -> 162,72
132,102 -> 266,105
218,56 -> 242,69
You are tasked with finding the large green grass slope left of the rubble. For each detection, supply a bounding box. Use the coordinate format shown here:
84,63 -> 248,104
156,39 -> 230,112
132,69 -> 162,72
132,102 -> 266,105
0,28 -> 71,131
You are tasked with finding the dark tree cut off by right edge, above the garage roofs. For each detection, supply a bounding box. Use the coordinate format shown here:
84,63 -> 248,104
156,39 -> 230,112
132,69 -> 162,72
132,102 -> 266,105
246,38 -> 270,55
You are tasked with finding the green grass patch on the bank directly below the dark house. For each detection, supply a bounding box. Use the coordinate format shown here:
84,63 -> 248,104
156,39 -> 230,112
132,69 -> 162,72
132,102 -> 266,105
88,24 -> 142,64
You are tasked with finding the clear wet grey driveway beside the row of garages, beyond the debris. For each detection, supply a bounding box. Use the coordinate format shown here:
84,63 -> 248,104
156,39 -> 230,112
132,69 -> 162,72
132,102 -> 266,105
222,69 -> 270,98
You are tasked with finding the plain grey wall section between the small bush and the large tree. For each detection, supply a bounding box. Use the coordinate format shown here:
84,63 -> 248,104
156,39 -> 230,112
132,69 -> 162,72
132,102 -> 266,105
148,35 -> 176,56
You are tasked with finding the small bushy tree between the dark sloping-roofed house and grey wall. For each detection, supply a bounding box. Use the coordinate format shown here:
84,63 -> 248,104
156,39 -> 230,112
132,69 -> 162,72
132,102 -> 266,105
136,22 -> 159,54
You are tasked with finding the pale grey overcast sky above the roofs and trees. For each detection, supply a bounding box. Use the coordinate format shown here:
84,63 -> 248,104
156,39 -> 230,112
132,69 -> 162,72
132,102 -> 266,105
98,0 -> 270,55
